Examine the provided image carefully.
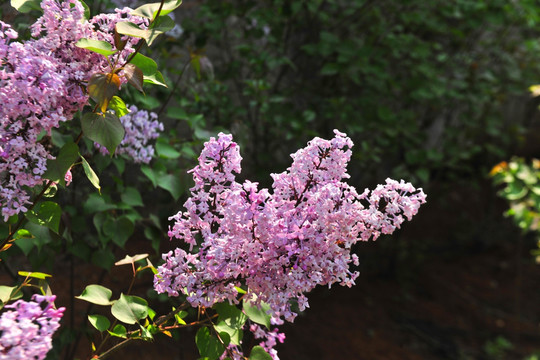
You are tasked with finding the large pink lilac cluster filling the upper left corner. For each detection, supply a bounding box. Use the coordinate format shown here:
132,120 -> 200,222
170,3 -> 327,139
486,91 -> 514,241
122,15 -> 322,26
0,0 -> 146,220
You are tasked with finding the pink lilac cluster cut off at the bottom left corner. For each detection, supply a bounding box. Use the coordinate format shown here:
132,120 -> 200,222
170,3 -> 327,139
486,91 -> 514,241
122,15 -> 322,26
0,295 -> 65,360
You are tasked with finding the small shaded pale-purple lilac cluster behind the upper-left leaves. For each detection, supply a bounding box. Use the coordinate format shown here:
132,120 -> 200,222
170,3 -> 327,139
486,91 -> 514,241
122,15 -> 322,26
94,105 -> 163,164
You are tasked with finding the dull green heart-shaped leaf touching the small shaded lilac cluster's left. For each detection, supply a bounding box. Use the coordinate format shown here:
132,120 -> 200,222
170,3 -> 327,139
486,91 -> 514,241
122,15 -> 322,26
81,113 -> 126,156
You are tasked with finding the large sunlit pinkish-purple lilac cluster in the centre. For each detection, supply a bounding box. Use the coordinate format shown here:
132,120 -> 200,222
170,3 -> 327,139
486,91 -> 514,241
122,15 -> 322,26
154,130 -> 426,324
